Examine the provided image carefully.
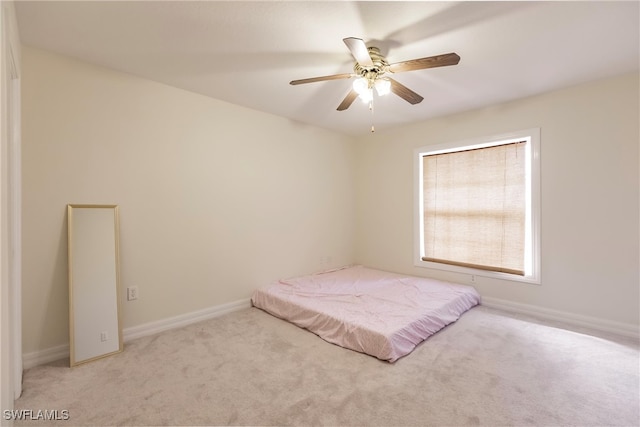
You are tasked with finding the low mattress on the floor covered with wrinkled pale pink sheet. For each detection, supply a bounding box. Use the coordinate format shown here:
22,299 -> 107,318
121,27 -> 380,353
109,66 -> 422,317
251,266 -> 480,362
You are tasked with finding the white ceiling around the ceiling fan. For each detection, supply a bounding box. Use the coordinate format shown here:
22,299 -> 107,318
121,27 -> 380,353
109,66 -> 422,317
16,1 -> 640,135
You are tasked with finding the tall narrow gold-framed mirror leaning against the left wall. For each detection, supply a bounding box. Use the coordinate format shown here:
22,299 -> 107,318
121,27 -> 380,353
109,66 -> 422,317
67,205 -> 123,366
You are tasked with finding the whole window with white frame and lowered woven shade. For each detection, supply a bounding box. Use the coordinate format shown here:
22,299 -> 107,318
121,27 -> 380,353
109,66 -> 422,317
414,129 -> 540,283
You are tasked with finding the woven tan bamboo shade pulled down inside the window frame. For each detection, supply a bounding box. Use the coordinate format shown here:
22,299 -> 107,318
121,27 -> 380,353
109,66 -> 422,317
422,141 -> 526,276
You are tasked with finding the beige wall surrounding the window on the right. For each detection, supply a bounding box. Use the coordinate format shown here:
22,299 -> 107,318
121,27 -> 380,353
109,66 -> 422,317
356,74 -> 640,328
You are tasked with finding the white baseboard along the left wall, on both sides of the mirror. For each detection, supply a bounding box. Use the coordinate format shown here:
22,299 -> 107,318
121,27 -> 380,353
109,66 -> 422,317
22,299 -> 251,369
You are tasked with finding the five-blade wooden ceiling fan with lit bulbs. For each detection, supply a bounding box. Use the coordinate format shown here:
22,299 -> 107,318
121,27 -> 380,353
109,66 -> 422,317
289,37 -> 460,111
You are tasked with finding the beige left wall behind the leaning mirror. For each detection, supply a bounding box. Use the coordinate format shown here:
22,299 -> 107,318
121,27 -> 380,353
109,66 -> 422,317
22,47 -> 354,353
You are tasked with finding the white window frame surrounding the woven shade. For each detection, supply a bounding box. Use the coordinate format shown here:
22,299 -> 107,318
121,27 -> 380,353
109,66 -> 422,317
413,128 -> 540,284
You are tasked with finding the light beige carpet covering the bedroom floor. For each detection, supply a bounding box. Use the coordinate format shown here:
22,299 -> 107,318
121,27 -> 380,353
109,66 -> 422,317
15,306 -> 640,426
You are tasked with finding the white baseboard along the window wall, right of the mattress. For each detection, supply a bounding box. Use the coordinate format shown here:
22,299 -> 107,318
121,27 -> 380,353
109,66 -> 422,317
482,297 -> 640,340
